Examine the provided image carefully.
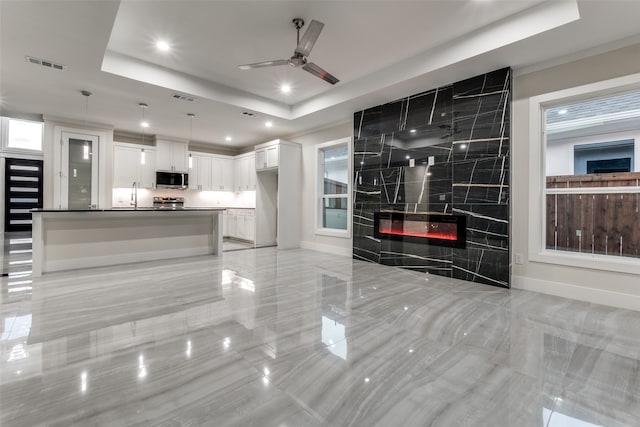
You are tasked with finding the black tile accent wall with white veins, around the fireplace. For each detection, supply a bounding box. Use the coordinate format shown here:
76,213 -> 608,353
353,68 -> 511,288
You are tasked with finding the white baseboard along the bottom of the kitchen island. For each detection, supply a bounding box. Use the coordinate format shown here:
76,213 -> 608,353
42,247 -> 211,273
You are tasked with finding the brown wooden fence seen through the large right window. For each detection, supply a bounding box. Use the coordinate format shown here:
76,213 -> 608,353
546,172 -> 640,258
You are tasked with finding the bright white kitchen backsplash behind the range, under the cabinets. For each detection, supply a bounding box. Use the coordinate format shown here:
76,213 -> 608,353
112,188 -> 256,209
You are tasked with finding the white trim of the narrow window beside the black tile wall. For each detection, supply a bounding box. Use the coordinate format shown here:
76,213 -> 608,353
314,137 -> 353,239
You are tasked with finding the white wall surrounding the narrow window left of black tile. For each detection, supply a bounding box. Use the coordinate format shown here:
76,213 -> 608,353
283,120 -> 353,256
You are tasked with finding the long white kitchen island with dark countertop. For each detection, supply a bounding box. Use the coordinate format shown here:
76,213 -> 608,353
32,208 -> 224,277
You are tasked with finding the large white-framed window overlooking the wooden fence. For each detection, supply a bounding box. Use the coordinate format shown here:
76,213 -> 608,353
529,75 -> 640,273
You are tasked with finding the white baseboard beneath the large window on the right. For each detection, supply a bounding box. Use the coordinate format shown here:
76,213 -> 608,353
511,275 -> 640,311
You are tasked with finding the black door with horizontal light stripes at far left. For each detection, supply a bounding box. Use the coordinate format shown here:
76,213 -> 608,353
4,159 -> 42,231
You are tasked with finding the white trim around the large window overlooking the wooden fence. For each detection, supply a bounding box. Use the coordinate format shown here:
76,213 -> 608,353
528,73 -> 640,274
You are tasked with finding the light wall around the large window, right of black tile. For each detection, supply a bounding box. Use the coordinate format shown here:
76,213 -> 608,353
511,44 -> 640,310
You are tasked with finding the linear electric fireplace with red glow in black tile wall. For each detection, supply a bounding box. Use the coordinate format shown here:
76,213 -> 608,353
373,212 -> 467,249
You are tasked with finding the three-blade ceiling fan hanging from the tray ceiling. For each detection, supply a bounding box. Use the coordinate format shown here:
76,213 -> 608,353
238,18 -> 340,85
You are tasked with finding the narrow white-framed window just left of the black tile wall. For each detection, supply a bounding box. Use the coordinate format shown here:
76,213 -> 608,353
316,138 -> 351,237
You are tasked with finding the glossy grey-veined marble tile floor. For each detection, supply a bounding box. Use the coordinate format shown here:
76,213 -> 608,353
0,248 -> 640,427
